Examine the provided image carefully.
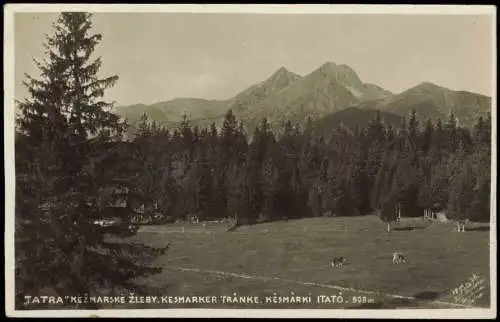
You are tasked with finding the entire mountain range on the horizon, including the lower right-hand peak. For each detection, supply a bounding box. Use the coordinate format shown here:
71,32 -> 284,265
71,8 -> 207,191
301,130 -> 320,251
115,62 -> 491,136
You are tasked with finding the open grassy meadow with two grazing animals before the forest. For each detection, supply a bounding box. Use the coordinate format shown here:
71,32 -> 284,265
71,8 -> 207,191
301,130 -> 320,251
111,216 -> 490,308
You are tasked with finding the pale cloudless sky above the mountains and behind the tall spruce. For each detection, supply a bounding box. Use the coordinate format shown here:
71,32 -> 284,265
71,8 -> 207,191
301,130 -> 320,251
14,13 -> 494,105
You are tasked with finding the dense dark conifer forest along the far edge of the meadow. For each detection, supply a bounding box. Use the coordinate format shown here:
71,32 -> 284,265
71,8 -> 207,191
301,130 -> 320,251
129,106 -> 491,231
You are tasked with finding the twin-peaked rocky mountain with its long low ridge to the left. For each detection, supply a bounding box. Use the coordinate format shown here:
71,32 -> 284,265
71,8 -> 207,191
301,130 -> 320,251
112,62 -> 392,130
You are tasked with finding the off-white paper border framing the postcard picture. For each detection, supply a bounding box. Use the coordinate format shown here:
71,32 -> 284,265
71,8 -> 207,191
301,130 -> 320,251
4,4 -> 497,319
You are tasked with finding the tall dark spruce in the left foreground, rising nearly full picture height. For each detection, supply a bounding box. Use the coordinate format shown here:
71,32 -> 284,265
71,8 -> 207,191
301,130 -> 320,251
15,12 -> 166,308
